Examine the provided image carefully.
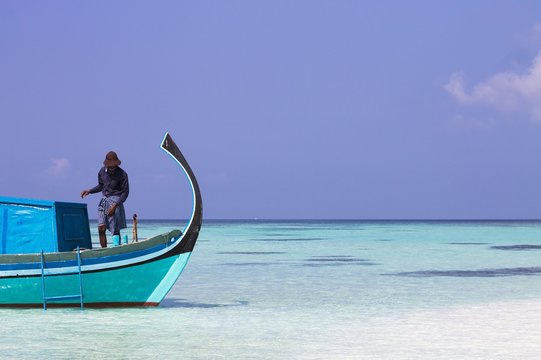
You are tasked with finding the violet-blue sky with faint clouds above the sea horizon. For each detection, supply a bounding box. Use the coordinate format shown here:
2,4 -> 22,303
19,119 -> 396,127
0,0 -> 541,219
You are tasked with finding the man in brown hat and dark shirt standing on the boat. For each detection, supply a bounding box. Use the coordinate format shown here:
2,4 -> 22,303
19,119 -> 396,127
81,151 -> 130,247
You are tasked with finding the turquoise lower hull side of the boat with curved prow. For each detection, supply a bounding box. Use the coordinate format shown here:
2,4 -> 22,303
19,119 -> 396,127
0,253 -> 191,307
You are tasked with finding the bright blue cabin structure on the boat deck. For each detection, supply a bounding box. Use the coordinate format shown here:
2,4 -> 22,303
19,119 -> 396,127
0,196 -> 92,254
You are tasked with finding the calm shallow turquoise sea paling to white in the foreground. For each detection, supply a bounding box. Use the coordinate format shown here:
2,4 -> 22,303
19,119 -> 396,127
0,221 -> 541,359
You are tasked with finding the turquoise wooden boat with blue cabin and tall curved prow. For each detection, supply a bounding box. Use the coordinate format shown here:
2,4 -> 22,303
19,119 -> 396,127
0,134 -> 202,308
